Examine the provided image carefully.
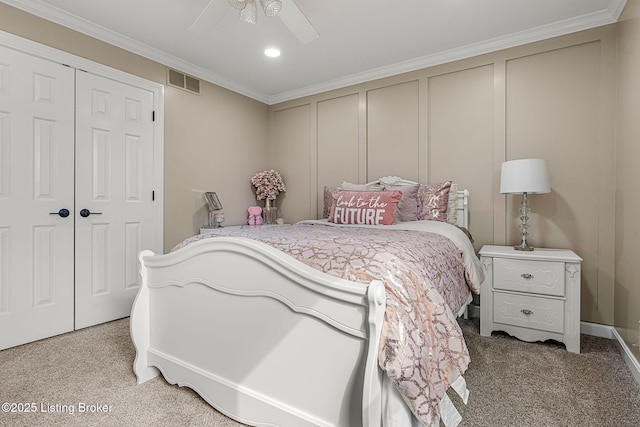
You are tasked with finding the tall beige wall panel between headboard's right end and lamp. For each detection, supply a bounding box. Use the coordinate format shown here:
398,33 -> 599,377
427,64 -> 500,250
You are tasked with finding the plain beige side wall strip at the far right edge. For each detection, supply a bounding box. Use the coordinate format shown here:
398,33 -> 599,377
614,0 -> 640,360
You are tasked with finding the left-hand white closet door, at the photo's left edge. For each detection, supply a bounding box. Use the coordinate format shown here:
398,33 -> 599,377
0,46 -> 75,349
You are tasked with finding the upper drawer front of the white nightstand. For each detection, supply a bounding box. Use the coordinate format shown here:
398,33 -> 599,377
493,258 -> 565,296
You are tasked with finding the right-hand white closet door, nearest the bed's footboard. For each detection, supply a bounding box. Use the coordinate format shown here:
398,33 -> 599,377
75,73 -> 155,329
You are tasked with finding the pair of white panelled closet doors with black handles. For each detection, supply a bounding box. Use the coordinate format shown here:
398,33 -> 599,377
0,46 -> 154,349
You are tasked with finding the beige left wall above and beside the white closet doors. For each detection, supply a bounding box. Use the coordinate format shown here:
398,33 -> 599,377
0,3 -> 269,251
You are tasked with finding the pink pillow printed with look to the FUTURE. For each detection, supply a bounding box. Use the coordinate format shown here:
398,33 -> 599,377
329,190 -> 402,225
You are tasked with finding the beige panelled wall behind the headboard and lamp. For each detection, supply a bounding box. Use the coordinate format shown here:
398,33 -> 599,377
270,26 -> 616,324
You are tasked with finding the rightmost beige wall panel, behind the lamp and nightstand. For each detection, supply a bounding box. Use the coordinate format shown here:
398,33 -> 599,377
506,40 -> 615,324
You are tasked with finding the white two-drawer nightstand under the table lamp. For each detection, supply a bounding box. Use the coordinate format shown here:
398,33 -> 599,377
480,245 -> 582,353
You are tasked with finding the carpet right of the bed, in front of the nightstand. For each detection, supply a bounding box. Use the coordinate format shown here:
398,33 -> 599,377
458,319 -> 640,427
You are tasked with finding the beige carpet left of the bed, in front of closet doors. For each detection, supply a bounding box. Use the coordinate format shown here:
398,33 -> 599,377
0,318 -> 242,427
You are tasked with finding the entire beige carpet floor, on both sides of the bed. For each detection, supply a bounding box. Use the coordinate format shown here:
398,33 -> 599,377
0,319 -> 640,427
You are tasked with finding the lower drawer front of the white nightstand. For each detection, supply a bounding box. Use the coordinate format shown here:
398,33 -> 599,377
493,292 -> 564,333
